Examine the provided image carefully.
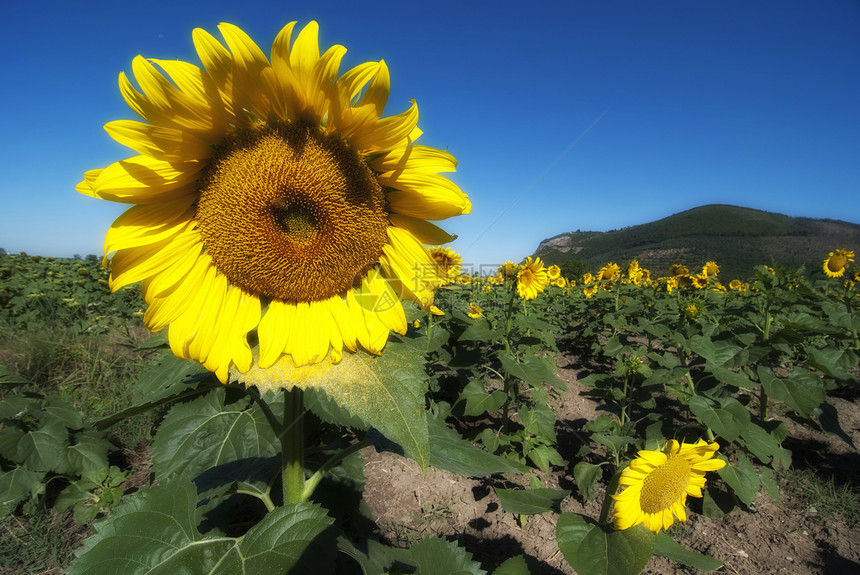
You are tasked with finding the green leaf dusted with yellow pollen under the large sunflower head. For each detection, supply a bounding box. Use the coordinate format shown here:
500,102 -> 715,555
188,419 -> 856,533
239,336 -> 430,469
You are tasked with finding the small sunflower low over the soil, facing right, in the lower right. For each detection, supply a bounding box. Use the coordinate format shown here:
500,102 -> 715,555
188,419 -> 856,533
612,439 -> 726,533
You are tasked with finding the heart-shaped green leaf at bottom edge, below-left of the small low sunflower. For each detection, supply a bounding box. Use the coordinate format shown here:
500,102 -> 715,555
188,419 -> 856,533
555,513 -> 654,575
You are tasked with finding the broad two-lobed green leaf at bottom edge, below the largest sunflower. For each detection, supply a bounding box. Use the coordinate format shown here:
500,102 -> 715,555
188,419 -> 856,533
68,477 -> 335,575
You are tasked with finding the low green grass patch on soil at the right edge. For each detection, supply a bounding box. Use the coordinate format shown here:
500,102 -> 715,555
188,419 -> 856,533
785,469 -> 860,528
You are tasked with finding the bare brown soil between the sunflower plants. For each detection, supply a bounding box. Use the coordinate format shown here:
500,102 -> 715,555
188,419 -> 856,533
362,358 -> 860,575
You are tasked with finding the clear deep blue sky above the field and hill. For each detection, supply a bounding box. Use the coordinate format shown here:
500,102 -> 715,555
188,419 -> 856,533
0,0 -> 860,272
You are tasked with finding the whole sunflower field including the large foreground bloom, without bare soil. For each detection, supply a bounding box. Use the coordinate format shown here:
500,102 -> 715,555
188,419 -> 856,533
0,18 -> 860,575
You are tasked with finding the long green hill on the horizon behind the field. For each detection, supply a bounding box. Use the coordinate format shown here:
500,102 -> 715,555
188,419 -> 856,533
534,204 -> 860,279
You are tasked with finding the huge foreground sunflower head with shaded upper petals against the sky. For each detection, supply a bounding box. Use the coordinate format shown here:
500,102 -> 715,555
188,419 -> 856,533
77,22 -> 471,382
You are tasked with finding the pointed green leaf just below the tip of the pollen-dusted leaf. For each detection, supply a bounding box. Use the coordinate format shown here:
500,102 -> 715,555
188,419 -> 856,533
427,417 -> 529,477
